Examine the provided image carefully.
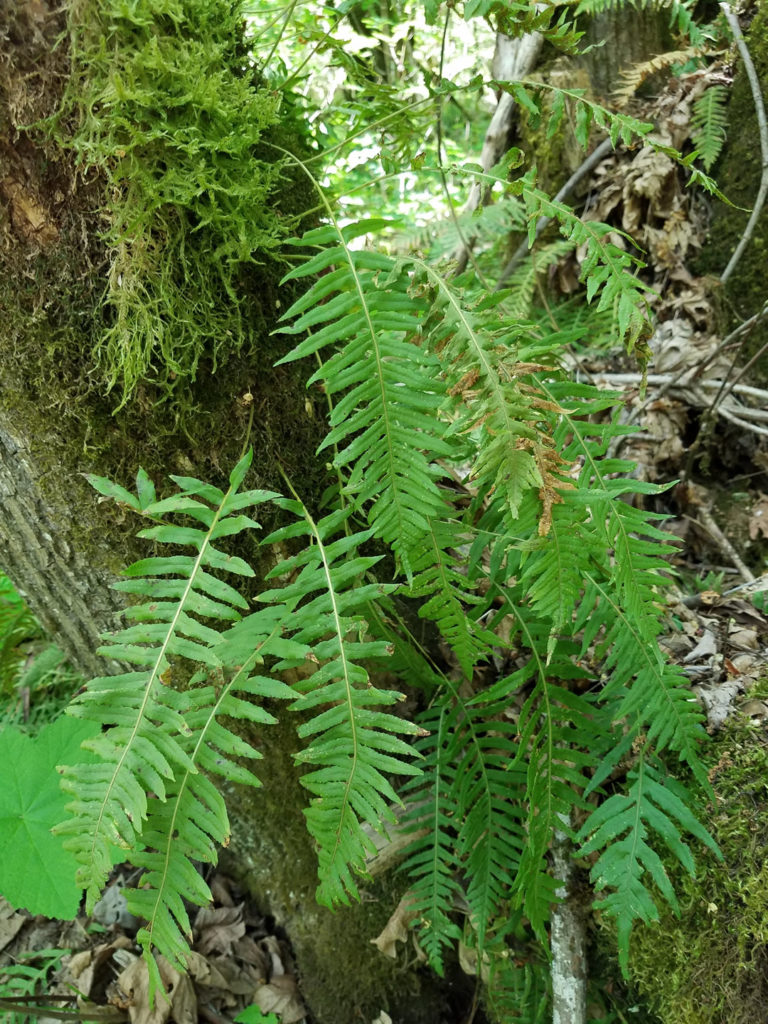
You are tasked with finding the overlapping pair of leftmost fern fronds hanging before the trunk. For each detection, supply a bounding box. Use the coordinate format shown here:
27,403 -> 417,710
59,453 -> 291,984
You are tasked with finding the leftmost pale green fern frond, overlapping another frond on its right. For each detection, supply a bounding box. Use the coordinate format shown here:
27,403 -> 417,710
59,453 -> 274,917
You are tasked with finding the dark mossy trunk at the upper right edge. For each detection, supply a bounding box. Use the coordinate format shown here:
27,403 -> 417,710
695,5 -> 768,383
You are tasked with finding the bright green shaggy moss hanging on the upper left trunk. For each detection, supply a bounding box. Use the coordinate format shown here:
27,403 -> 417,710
49,0 -> 307,404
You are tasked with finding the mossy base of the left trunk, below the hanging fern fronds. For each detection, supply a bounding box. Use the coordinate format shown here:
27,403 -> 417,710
222,716 -> 474,1024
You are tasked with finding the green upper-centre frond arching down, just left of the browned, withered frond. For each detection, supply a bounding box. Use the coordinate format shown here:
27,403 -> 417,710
281,221 -> 451,575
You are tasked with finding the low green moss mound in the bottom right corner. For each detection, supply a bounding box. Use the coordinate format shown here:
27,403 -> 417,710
618,679 -> 768,1024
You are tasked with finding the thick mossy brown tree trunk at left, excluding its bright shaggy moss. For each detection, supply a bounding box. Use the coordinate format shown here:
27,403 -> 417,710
0,0 -> 450,1024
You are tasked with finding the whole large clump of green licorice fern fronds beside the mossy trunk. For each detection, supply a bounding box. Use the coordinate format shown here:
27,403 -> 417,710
45,0 -> 729,998
